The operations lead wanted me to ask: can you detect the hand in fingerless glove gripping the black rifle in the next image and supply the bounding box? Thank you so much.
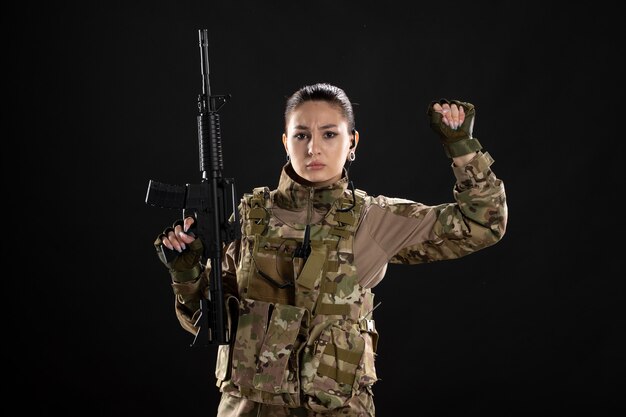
[154,218,203,282]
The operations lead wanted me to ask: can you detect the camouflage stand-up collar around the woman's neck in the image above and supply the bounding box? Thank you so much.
[274,162,348,211]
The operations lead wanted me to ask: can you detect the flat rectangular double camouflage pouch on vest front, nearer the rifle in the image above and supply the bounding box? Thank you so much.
[232,299,309,406]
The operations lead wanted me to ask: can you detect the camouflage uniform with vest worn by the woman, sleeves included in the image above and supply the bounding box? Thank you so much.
[168,152,507,416]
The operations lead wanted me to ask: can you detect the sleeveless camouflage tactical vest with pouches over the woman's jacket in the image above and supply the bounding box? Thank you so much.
[216,187,378,411]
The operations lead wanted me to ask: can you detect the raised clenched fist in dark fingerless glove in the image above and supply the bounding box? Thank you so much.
[427,98,482,158]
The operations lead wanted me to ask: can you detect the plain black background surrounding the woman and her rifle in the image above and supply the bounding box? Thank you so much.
[8,0,624,417]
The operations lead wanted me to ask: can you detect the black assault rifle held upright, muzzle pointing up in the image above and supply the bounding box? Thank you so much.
[146,29,241,346]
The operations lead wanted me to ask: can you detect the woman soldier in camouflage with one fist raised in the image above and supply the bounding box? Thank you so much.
[155,83,507,417]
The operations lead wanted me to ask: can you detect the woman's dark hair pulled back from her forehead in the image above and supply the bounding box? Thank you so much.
[285,83,354,132]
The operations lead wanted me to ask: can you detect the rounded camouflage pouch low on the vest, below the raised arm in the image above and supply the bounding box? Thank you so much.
[300,320,366,411]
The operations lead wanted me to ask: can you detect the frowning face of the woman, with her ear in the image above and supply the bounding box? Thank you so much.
[283,101,359,186]
